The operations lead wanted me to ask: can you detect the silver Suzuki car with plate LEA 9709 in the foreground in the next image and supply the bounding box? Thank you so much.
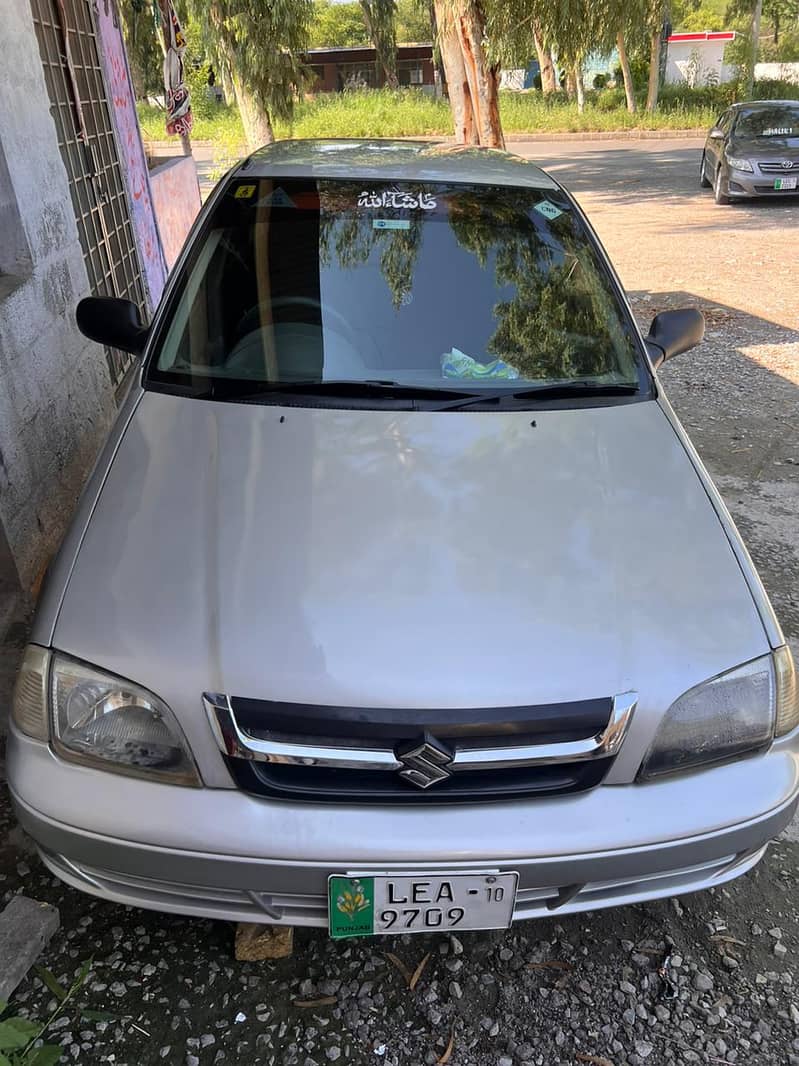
[9,141,799,937]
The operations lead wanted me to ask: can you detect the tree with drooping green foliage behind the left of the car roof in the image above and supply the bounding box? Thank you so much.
[187,0,313,149]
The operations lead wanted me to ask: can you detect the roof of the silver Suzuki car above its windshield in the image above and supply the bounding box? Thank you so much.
[232,139,559,189]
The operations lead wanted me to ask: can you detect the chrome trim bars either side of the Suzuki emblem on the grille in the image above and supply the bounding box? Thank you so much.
[202,692,638,773]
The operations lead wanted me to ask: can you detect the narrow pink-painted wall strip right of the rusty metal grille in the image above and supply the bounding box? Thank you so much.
[95,0,166,307]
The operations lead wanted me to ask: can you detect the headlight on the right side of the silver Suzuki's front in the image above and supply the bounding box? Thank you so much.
[640,648,784,777]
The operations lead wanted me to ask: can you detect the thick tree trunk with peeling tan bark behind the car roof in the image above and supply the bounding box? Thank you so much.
[436,0,505,148]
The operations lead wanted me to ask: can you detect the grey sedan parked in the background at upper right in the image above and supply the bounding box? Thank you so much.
[699,100,799,204]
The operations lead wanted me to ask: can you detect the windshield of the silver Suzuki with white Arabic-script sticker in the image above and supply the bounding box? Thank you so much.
[146,178,639,399]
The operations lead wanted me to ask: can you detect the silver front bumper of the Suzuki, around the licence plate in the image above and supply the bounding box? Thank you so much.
[9,732,799,925]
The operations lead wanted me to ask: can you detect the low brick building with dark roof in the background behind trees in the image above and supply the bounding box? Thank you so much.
[304,45,436,93]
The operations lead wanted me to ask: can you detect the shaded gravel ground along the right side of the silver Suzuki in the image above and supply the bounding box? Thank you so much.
[630,291,799,640]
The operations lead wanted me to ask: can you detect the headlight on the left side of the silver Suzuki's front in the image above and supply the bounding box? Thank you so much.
[12,645,200,786]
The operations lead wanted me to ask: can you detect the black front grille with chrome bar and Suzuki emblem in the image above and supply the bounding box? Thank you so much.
[205,693,635,806]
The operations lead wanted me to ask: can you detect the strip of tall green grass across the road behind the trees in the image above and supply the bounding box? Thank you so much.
[138,77,796,146]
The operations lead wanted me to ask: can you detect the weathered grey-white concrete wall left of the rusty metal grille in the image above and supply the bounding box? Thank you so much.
[0,0,115,587]
